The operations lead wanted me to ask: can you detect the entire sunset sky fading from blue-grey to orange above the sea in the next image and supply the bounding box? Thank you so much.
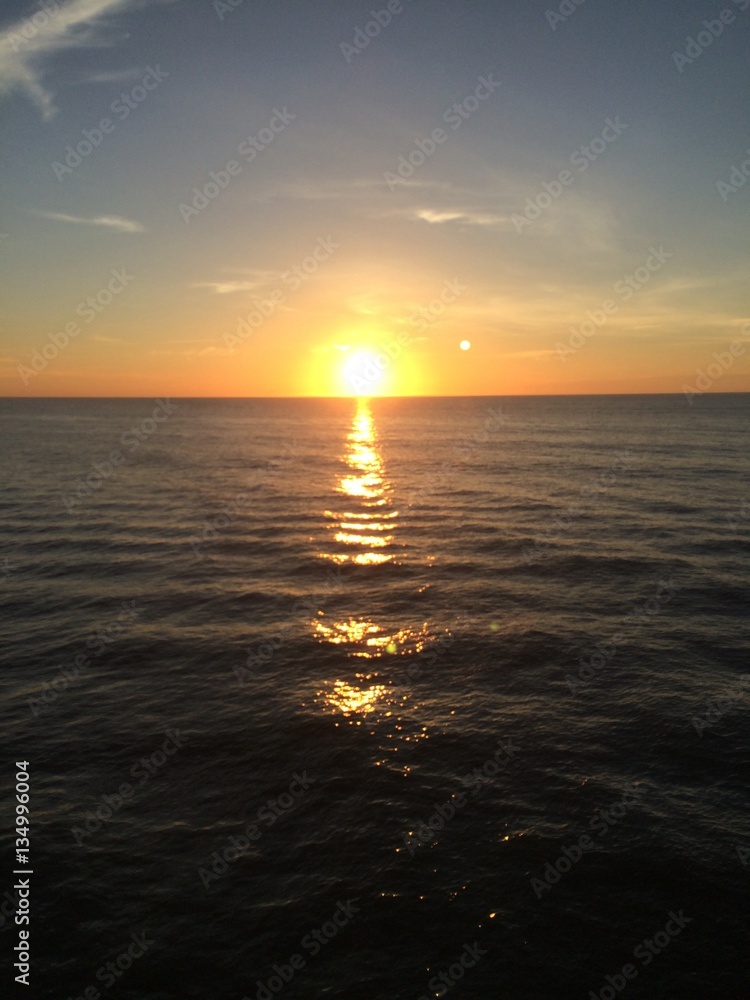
[0,0,750,396]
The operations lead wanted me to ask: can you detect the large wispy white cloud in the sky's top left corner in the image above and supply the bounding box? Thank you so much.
[0,0,164,120]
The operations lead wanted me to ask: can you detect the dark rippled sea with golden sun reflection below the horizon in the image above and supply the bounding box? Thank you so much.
[0,395,750,1000]
